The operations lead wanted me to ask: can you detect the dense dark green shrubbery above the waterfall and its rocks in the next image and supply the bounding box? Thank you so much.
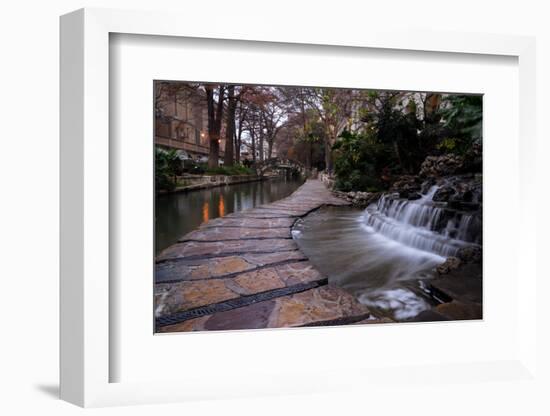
[333,92,483,191]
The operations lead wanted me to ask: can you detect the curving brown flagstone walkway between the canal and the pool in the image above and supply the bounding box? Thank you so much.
[155,180,376,332]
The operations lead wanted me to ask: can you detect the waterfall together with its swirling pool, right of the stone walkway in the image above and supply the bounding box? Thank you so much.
[293,186,478,320]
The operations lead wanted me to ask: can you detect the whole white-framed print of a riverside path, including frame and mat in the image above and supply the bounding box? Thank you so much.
[61,9,537,406]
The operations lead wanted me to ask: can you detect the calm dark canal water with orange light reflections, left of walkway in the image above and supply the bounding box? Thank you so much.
[155,177,303,254]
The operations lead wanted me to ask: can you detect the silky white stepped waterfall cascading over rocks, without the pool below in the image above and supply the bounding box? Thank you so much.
[363,186,480,257]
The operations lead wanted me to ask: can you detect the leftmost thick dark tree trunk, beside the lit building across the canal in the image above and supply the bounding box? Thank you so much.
[204,84,225,168]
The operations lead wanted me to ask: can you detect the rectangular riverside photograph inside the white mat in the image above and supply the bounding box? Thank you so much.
[151,80,483,333]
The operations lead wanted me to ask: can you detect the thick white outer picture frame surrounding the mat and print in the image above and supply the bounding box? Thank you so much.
[60,9,540,406]
